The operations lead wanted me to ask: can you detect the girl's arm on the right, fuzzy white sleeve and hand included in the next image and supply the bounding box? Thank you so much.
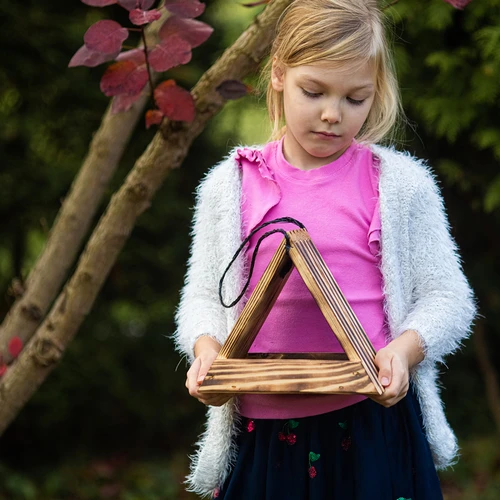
[373,164,476,406]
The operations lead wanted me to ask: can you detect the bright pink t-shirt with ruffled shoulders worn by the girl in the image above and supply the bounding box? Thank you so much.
[237,139,386,419]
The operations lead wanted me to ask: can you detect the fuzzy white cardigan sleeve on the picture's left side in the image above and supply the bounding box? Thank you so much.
[173,164,240,363]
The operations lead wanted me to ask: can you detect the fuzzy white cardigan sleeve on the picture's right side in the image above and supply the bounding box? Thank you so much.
[399,170,476,362]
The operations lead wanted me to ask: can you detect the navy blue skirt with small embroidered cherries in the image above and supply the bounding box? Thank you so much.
[214,388,443,500]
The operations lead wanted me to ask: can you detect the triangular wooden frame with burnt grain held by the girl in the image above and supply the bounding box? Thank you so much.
[199,229,384,394]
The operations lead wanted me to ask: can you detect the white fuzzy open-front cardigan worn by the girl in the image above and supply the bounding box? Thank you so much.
[174,146,476,496]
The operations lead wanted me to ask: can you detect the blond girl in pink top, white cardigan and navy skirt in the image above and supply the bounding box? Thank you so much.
[175,0,475,500]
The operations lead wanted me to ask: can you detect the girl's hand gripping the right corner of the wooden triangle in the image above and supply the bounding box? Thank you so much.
[370,330,424,408]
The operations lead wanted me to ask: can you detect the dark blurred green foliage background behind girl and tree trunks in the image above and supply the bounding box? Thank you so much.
[0,0,500,500]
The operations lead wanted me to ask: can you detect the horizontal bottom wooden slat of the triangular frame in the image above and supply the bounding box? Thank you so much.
[199,359,378,394]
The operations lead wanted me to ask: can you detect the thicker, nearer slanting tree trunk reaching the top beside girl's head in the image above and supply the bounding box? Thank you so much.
[0,0,291,433]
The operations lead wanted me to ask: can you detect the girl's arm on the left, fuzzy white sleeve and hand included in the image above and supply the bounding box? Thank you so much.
[174,158,240,406]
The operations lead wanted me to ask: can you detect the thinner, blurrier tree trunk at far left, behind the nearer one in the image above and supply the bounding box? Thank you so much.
[0,11,165,363]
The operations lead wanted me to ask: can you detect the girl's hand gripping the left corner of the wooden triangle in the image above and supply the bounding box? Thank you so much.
[186,337,233,406]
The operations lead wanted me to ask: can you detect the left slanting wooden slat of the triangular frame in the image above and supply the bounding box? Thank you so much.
[218,239,293,359]
